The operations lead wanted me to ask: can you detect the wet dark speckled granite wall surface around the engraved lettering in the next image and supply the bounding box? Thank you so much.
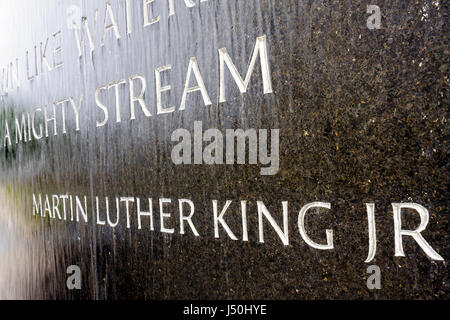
[0,0,450,299]
